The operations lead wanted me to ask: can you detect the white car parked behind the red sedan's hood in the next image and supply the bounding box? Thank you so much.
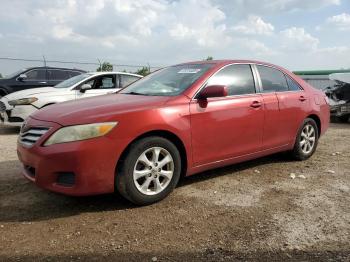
[0,72,142,126]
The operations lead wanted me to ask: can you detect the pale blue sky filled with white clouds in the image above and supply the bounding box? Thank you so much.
[0,0,350,74]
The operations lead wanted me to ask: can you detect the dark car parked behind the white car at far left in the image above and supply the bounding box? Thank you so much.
[0,67,86,97]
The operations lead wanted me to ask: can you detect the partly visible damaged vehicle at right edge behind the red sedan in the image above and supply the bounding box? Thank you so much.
[324,73,350,123]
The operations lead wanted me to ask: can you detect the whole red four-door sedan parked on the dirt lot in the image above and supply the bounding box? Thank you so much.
[17,60,329,205]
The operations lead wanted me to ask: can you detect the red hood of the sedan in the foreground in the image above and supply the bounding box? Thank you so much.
[31,94,169,126]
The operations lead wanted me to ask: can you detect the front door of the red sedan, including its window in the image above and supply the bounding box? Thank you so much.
[190,64,264,165]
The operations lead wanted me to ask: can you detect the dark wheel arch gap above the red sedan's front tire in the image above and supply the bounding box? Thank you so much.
[116,130,188,180]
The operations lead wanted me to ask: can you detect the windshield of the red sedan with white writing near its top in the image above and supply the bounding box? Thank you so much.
[120,64,213,96]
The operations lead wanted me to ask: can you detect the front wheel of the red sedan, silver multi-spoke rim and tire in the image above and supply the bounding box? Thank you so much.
[116,136,181,205]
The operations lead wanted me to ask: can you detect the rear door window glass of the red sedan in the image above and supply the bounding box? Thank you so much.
[257,65,288,93]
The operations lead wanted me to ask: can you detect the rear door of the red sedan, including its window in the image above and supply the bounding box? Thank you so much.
[256,65,306,149]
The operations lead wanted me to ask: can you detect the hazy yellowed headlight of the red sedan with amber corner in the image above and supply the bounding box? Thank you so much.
[44,122,118,146]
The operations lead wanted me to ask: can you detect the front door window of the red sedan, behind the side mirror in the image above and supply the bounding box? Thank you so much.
[207,65,255,96]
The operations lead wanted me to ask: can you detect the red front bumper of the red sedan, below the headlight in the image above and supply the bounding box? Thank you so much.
[17,118,120,196]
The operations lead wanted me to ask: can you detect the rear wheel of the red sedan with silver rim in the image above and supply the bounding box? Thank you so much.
[292,118,319,160]
